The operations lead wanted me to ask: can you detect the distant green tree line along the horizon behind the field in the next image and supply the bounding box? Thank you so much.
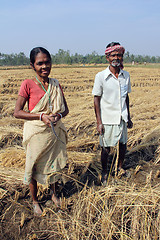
[0,49,160,66]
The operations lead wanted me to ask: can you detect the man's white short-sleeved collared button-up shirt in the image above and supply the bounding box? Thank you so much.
[92,67,131,125]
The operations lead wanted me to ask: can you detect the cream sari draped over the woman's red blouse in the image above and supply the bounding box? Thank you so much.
[23,78,67,184]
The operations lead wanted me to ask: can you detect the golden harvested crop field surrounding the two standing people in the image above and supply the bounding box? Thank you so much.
[0,65,160,239]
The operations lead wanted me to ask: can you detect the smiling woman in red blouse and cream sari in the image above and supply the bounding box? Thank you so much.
[14,47,69,215]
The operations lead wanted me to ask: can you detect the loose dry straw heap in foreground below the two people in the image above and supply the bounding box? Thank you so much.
[0,175,160,240]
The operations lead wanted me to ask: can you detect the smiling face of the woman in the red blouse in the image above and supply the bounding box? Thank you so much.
[32,52,52,78]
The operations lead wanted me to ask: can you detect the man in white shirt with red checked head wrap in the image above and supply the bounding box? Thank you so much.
[92,42,133,182]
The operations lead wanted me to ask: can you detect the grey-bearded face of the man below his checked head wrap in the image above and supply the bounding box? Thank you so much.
[106,51,123,67]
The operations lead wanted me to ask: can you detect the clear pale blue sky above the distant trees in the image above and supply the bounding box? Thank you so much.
[0,0,160,56]
